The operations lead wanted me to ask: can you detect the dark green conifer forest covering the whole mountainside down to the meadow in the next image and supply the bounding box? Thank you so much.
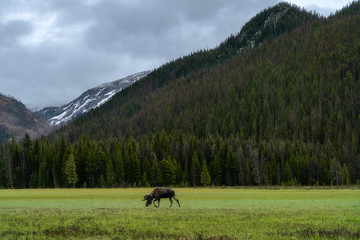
[0,2,360,188]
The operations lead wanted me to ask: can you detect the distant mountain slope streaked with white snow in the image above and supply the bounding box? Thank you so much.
[36,71,150,127]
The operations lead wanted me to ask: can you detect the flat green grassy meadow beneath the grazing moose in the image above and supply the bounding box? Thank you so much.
[0,188,360,239]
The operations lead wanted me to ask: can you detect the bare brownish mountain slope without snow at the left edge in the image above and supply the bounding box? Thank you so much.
[0,94,51,143]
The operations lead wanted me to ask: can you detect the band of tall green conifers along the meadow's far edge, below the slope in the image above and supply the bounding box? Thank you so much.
[0,131,360,188]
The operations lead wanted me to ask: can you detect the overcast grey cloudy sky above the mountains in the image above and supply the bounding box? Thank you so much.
[0,0,351,110]
